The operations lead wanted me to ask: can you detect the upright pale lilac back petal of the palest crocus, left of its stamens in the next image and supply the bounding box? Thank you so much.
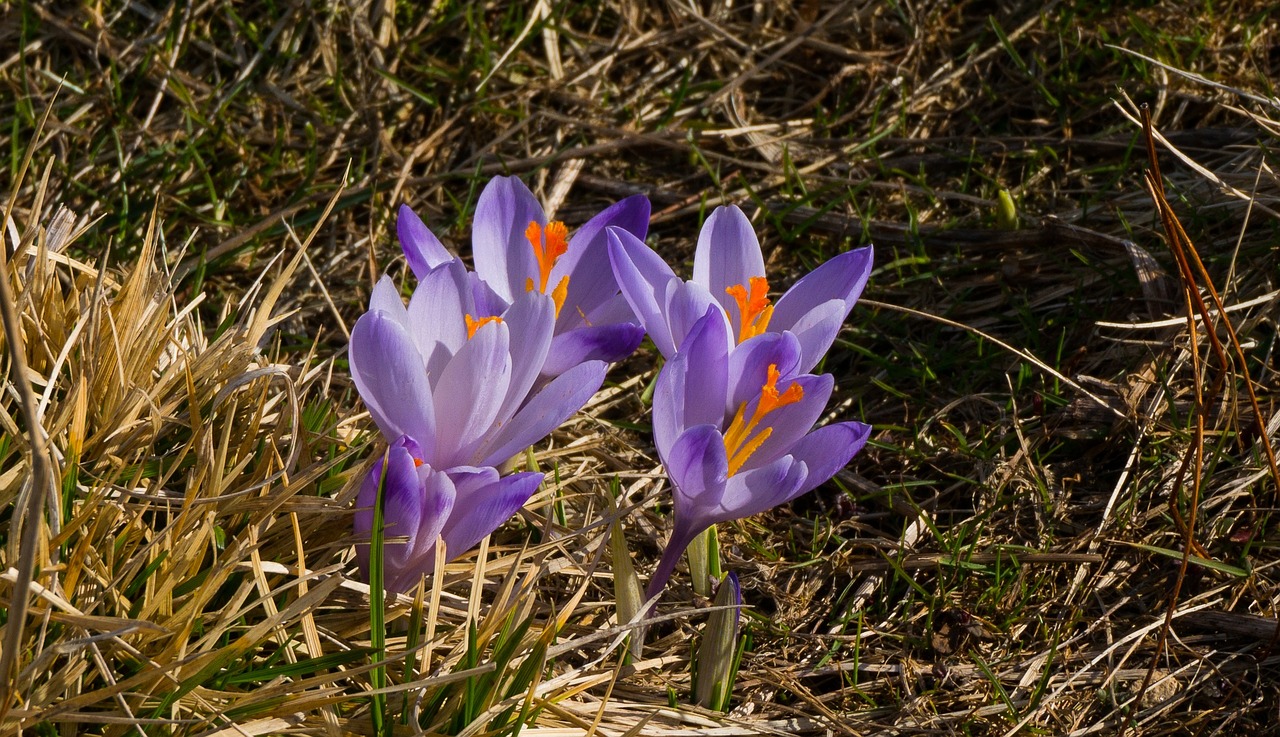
[406,261,468,376]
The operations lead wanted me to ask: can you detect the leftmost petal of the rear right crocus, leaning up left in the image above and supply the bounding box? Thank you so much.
[605,228,680,358]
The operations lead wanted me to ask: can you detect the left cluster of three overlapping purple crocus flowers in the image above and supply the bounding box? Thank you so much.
[349,178,649,591]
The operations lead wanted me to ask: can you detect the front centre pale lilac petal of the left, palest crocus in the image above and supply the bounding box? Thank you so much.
[431,322,511,466]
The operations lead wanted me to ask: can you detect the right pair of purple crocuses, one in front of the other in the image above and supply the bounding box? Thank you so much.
[609,206,872,596]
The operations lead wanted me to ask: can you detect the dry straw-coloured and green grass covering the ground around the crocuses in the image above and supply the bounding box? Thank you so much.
[0,0,1280,736]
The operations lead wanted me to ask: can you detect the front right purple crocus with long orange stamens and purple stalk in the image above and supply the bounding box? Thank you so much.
[648,307,870,598]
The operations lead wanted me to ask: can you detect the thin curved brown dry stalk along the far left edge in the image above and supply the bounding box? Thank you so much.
[0,92,58,720]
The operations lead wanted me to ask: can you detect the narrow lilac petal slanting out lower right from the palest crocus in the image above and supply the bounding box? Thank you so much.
[472,361,605,466]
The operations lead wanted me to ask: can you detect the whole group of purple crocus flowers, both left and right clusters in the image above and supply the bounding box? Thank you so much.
[349,177,872,598]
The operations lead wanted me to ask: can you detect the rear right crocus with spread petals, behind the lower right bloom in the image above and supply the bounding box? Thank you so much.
[608,205,872,372]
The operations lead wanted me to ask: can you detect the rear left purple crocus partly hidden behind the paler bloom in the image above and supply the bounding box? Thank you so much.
[397,177,649,376]
